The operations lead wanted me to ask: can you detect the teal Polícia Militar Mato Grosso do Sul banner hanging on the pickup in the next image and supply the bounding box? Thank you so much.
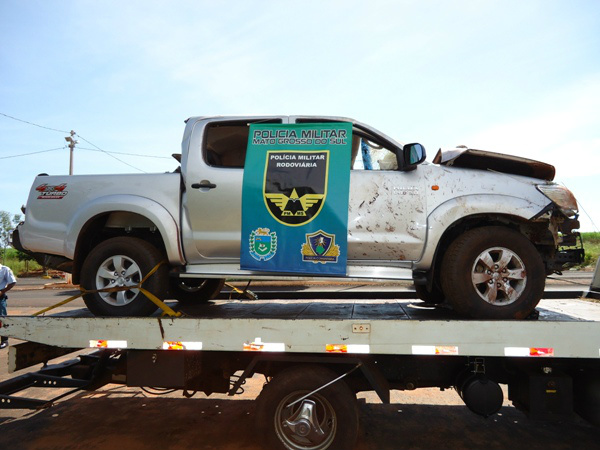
[240,123,352,275]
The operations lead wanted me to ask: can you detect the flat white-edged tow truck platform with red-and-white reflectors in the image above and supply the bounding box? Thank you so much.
[0,299,600,359]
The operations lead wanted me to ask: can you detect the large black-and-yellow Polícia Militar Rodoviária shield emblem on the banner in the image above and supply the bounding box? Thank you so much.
[263,150,329,227]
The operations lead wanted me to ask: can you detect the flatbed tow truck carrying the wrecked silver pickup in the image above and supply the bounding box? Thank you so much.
[0,269,600,449]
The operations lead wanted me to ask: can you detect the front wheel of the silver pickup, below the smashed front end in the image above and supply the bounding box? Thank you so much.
[441,226,546,319]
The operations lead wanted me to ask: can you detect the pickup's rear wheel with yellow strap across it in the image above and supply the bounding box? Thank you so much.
[81,237,168,317]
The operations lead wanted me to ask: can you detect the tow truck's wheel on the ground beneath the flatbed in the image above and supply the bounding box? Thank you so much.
[256,366,358,450]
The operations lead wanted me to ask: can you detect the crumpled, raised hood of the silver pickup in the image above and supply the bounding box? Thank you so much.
[433,148,556,181]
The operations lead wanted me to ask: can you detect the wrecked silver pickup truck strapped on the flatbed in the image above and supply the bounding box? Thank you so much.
[13,116,583,319]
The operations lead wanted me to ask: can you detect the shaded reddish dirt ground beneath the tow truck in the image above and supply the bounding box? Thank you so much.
[0,366,600,450]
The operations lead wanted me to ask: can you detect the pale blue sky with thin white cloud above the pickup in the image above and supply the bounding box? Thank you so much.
[0,0,600,231]
